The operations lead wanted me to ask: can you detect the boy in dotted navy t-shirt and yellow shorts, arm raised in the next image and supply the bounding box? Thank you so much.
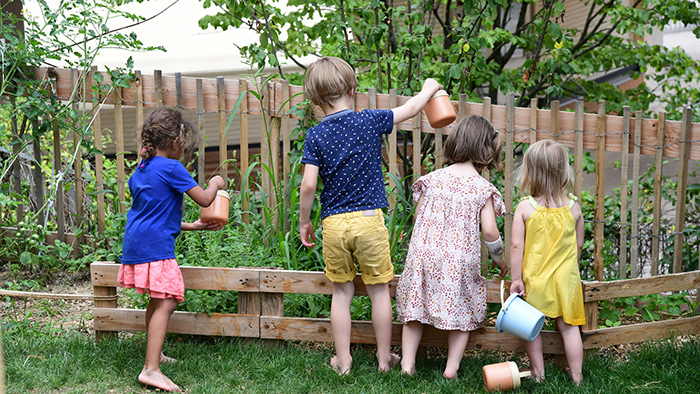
[299,57,441,375]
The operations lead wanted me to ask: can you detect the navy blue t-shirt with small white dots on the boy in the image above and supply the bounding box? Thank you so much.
[301,109,394,218]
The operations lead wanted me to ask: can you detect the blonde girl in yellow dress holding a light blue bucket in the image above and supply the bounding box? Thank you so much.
[510,140,586,384]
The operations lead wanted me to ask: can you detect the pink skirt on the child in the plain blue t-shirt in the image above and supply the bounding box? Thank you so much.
[118,259,185,302]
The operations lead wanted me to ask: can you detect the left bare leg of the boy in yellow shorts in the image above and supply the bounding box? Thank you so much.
[331,282,355,375]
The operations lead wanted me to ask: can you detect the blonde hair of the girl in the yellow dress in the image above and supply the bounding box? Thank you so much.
[518,140,574,207]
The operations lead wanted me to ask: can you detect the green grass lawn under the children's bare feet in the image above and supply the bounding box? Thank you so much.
[3,329,700,394]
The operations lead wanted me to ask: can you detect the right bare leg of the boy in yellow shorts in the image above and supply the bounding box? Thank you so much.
[367,283,399,372]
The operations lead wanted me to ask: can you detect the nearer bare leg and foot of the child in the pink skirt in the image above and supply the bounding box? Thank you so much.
[138,298,181,392]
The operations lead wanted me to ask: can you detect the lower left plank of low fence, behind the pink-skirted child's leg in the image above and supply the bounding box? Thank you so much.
[93,308,260,338]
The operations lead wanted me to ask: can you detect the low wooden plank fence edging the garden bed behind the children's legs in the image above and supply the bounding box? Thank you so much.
[90,262,700,354]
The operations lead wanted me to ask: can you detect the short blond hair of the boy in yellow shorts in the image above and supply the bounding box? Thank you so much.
[304,56,357,107]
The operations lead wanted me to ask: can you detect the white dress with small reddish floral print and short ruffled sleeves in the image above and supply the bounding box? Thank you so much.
[396,169,505,331]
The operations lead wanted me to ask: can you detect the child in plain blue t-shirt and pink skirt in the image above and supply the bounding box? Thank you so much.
[119,107,225,392]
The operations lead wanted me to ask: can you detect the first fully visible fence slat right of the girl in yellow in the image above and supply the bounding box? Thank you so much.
[593,100,606,281]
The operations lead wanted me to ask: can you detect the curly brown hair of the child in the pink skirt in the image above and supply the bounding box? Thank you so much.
[138,107,198,159]
